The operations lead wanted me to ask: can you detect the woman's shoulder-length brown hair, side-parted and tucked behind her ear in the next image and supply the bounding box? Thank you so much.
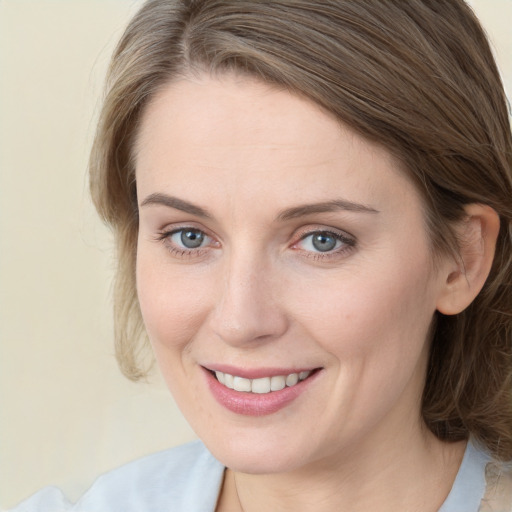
[90,0,512,459]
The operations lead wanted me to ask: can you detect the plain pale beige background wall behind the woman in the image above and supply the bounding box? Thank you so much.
[0,0,512,508]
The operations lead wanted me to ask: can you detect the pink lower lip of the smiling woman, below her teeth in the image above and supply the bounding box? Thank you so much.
[205,370,319,416]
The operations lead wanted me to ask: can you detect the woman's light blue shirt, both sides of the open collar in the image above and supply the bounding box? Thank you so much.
[11,441,512,512]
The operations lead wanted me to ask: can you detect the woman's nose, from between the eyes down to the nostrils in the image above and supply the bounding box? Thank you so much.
[207,249,288,346]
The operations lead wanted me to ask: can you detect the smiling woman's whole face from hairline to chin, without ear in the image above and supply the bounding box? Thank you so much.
[136,76,444,473]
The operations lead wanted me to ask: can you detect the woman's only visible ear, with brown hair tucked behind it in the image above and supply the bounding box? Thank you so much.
[437,204,500,315]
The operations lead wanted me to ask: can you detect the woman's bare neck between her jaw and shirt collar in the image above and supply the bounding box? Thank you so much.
[217,432,465,512]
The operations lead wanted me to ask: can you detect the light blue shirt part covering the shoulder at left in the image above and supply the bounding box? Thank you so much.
[12,441,224,512]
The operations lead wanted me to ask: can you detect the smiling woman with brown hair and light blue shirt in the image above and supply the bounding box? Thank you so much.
[13,0,512,512]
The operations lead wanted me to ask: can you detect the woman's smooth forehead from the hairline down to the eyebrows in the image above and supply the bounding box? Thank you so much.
[135,72,422,216]
